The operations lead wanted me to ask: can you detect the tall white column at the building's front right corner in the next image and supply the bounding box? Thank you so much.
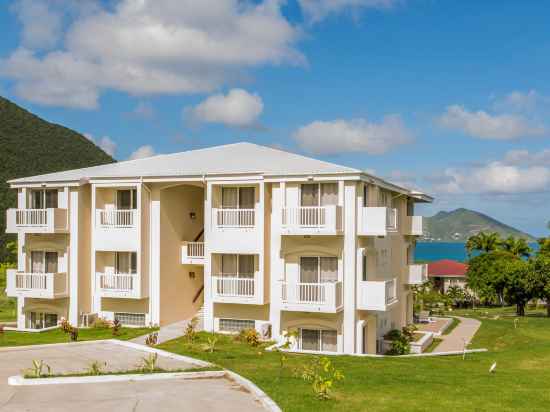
[339,181,357,354]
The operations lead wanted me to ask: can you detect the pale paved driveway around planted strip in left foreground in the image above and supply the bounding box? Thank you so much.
[0,342,265,412]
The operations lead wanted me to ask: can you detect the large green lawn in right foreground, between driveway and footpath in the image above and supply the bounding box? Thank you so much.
[159,308,550,412]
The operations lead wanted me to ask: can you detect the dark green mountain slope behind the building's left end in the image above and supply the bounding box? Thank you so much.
[0,96,114,262]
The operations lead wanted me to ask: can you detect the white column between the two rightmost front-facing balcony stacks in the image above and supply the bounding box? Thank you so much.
[269,182,286,339]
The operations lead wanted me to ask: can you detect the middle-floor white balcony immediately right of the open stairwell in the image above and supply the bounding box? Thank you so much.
[212,275,258,303]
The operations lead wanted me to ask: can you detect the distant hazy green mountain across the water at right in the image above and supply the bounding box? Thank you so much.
[424,208,535,242]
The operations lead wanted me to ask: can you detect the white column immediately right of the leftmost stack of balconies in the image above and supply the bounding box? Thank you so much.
[69,188,80,325]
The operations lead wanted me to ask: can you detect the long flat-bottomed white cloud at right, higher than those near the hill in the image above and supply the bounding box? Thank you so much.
[438,105,546,140]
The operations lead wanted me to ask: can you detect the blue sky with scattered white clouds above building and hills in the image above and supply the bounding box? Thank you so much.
[0,0,550,235]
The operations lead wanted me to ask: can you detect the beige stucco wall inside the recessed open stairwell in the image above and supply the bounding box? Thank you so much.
[160,185,204,325]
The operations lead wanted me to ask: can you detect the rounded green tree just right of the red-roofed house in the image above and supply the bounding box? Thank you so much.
[467,250,519,304]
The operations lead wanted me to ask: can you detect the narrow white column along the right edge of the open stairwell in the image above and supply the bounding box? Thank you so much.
[203,182,214,332]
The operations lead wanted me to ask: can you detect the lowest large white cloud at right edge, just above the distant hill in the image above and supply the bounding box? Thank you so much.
[434,161,550,194]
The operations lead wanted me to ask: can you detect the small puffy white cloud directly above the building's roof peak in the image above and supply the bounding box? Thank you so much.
[184,89,264,127]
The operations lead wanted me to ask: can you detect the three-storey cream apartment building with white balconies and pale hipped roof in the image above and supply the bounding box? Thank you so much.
[7,143,432,354]
